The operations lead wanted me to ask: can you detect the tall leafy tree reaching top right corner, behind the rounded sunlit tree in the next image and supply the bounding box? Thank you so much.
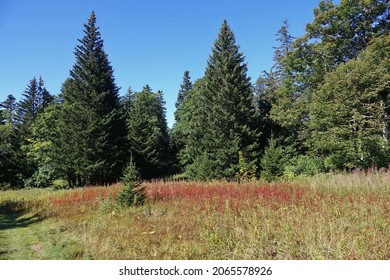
[271,0,390,153]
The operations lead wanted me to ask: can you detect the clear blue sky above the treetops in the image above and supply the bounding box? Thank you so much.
[0,0,326,126]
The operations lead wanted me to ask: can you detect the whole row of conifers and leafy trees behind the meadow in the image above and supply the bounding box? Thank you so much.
[0,0,390,188]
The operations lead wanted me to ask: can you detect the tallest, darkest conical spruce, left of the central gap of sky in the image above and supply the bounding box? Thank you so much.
[59,12,127,185]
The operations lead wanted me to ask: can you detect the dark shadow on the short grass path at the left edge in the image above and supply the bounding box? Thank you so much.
[0,201,43,231]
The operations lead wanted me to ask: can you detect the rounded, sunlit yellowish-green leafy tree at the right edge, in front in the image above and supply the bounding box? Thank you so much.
[310,36,390,168]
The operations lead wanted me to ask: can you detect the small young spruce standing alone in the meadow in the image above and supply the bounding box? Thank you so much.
[116,159,146,207]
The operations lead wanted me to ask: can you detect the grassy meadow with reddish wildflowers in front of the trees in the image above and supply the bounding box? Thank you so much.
[0,170,390,260]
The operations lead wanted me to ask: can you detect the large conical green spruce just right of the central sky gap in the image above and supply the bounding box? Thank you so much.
[183,21,259,179]
